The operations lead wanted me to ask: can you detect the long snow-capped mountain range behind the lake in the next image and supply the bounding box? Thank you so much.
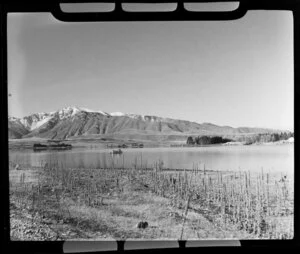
[8,106,279,140]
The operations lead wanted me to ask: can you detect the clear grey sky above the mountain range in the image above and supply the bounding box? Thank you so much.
[8,7,294,131]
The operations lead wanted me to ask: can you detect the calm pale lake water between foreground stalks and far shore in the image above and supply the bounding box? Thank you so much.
[9,144,294,174]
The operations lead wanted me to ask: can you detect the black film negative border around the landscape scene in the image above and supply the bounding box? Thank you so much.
[1,0,300,253]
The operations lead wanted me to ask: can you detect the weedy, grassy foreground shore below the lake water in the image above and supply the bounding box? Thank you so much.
[10,162,293,240]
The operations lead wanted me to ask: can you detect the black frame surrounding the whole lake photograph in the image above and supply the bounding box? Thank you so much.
[0,0,300,253]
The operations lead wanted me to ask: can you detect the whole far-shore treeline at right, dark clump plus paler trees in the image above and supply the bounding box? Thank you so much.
[186,132,294,145]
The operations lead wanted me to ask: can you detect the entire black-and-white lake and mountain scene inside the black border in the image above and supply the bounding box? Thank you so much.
[7,3,294,241]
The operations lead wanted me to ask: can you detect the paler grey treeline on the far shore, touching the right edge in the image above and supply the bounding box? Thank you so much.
[237,132,294,145]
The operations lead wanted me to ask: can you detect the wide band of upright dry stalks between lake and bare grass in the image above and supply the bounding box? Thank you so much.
[9,157,293,239]
